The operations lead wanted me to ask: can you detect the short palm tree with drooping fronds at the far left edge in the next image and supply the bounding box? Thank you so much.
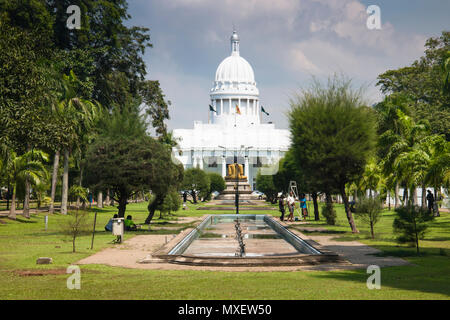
[7,151,48,219]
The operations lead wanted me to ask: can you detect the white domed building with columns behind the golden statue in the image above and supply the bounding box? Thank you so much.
[173,31,290,189]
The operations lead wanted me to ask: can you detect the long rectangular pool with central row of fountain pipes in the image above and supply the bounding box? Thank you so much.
[169,214,322,259]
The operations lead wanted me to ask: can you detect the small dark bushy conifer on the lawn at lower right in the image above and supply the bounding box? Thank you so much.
[393,205,434,254]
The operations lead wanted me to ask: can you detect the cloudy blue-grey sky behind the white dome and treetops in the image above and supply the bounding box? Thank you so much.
[128,0,450,129]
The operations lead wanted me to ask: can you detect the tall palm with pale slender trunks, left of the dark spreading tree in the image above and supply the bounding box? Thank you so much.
[50,71,98,214]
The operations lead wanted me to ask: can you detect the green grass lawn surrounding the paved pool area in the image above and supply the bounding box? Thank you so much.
[0,203,450,300]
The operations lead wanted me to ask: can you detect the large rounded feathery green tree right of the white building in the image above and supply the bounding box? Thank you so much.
[289,77,376,233]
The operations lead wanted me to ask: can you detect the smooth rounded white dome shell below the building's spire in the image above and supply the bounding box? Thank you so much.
[215,55,255,85]
